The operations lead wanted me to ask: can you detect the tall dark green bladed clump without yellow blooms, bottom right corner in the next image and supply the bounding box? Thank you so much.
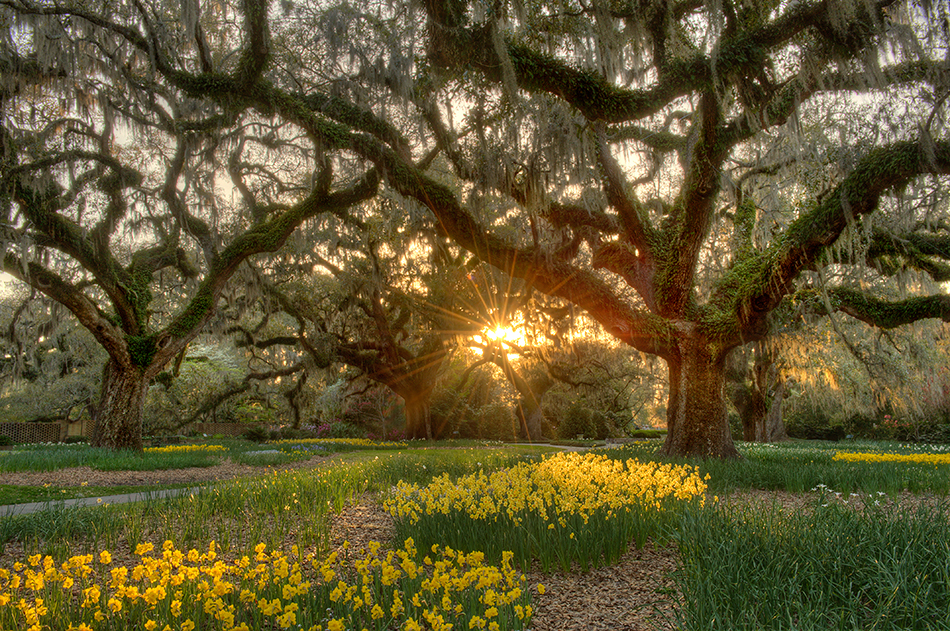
[676,503,950,631]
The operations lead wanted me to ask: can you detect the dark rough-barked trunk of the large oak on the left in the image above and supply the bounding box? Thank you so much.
[92,359,148,451]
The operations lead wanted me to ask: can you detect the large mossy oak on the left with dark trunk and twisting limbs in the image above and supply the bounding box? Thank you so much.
[0,0,378,449]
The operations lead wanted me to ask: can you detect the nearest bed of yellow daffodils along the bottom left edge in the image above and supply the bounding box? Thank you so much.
[0,539,543,631]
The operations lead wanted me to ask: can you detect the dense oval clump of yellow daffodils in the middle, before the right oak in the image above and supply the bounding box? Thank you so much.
[385,453,706,571]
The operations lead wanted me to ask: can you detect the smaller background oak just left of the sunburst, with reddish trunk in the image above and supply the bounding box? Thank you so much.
[238,212,466,439]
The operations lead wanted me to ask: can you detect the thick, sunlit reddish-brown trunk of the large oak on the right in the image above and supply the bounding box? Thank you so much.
[661,337,741,458]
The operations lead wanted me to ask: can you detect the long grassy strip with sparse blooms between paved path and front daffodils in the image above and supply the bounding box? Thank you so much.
[0,447,552,554]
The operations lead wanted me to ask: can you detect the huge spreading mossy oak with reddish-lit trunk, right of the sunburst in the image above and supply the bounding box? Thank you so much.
[404,0,950,457]
